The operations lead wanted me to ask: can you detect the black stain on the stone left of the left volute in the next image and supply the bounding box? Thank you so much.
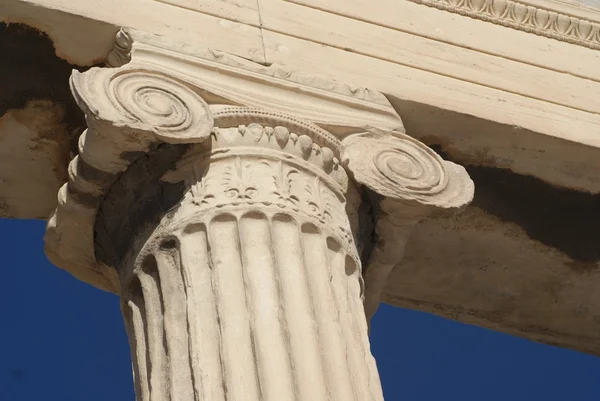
[0,23,85,153]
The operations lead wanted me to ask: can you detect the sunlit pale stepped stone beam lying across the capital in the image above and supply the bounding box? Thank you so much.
[0,0,600,156]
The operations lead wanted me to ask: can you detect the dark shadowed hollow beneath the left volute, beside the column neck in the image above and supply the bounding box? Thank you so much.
[94,144,189,268]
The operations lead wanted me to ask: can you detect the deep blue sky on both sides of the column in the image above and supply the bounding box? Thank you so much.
[0,219,600,401]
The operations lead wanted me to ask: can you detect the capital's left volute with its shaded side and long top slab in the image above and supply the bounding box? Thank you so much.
[45,30,403,292]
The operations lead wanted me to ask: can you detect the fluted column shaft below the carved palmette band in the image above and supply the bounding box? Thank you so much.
[124,212,380,401]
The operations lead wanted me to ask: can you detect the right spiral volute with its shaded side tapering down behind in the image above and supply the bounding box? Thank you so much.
[342,129,474,318]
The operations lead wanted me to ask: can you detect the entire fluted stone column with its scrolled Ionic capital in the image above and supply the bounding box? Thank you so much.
[45,30,474,401]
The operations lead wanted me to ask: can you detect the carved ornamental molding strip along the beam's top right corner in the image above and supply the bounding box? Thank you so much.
[409,0,600,50]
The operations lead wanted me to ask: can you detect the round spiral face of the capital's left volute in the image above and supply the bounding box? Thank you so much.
[71,68,213,143]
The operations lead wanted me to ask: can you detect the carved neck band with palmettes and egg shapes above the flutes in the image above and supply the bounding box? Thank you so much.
[163,120,358,247]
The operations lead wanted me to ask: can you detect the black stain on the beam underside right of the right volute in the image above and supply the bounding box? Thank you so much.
[430,144,600,266]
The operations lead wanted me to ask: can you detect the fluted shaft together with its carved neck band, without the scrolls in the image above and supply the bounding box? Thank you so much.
[122,119,383,401]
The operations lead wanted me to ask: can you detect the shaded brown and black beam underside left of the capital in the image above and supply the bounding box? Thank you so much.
[0,24,84,219]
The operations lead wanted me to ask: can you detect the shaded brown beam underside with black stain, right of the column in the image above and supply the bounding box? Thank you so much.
[383,166,600,354]
